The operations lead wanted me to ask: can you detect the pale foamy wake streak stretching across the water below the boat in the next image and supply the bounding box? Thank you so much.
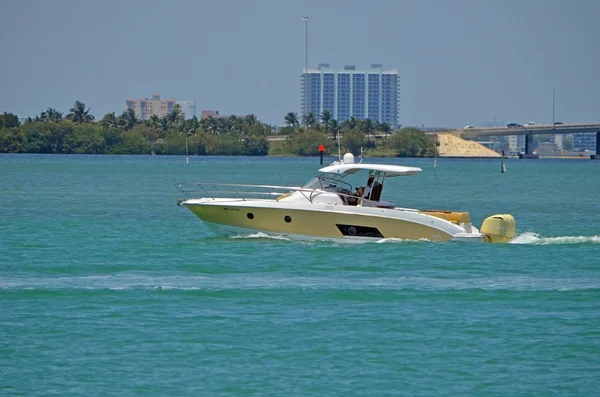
[0,271,600,290]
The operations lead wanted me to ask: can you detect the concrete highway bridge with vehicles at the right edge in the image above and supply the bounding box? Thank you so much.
[450,124,600,160]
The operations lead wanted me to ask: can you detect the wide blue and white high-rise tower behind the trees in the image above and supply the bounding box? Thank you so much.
[300,63,400,127]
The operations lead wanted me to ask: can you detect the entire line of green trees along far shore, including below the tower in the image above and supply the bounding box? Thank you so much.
[0,105,435,157]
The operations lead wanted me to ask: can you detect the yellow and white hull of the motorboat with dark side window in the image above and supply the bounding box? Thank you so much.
[183,199,482,243]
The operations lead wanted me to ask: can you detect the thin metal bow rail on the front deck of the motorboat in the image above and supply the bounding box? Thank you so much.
[175,182,317,205]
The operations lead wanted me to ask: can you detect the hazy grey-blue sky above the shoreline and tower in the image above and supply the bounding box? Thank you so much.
[0,0,600,128]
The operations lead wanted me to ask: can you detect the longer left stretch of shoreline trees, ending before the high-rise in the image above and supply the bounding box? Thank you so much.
[0,101,272,156]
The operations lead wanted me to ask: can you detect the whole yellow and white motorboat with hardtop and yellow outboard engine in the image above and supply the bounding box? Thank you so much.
[175,153,515,243]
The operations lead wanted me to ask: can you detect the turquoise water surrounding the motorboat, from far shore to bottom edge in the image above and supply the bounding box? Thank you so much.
[0,155,600,396]
